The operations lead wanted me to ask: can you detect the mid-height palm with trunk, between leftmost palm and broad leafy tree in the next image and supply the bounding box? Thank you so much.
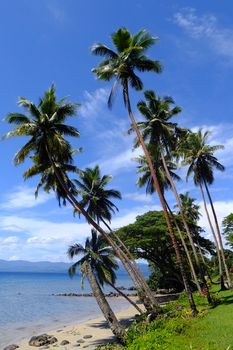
[74,165,159,310]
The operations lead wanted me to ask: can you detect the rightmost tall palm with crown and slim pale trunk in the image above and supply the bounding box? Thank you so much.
[181,129,231,286]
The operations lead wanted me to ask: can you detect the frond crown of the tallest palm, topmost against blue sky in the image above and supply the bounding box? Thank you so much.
[91,28,162,106]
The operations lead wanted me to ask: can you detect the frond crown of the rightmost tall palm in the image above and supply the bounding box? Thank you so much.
[181,129,225,185]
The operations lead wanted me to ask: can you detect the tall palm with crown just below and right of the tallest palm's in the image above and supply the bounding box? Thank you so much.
[135,90,211,303]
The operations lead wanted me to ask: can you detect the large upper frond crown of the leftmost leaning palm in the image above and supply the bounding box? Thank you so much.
[5,85,79,164]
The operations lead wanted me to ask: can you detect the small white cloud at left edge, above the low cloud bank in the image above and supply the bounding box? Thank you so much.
[0,186,51,211]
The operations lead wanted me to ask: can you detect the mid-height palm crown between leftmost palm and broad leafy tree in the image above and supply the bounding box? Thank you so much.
[74,165,121,223]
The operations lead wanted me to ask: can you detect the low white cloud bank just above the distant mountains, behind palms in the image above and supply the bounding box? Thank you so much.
[0,201,159,261]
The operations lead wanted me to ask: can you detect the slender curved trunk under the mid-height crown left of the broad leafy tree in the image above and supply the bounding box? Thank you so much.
[102,219,157,308]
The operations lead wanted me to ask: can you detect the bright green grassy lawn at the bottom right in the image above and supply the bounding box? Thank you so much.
[124,288,233,350]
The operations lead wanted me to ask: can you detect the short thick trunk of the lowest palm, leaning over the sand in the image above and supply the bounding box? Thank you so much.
[85,263,125,342]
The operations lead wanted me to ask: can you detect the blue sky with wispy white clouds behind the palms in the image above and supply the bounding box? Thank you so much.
[0,0,233,261]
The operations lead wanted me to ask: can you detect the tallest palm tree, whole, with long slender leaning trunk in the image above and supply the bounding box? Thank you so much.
[92,28,197,314]
